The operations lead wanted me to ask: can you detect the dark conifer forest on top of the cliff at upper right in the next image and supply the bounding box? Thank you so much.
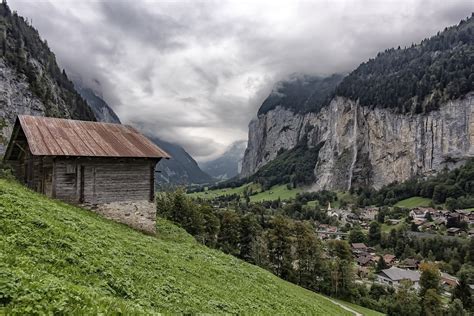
[335,16,474,113]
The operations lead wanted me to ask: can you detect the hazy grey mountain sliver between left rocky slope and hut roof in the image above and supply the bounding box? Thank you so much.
[73,78,120,124]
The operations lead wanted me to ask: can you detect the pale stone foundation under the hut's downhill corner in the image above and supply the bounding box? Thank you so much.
[88,201,156,234]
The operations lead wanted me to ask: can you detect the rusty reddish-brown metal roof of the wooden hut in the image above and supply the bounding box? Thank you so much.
[18,115,170,158]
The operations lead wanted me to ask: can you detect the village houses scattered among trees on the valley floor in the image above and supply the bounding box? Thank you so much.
[316,204,474,297]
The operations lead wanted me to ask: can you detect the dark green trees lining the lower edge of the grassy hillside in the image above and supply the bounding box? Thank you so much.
[156,190,474,315]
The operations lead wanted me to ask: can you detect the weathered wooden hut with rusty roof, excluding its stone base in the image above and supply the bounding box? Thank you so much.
[4,115,170,204]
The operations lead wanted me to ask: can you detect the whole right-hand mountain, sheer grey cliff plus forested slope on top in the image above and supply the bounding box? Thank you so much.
[241,17,474,190]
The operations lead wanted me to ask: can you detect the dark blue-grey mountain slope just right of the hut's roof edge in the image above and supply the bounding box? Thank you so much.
[151,137,214,186]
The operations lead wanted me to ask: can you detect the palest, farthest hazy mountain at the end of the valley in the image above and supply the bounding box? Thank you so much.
[200,140,247,180]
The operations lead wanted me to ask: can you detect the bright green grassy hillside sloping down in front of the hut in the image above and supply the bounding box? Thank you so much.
[0,180,350,315]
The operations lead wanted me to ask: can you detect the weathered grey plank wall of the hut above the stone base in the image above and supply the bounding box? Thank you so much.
[53,158,157,204]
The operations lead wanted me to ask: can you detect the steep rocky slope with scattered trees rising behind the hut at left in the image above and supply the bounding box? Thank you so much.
[0,1,96,155]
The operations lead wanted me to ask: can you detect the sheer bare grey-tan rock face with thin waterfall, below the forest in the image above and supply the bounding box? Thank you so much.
[241,93,474,190]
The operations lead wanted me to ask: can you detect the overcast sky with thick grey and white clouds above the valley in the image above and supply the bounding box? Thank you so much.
[8,0,474,160]
